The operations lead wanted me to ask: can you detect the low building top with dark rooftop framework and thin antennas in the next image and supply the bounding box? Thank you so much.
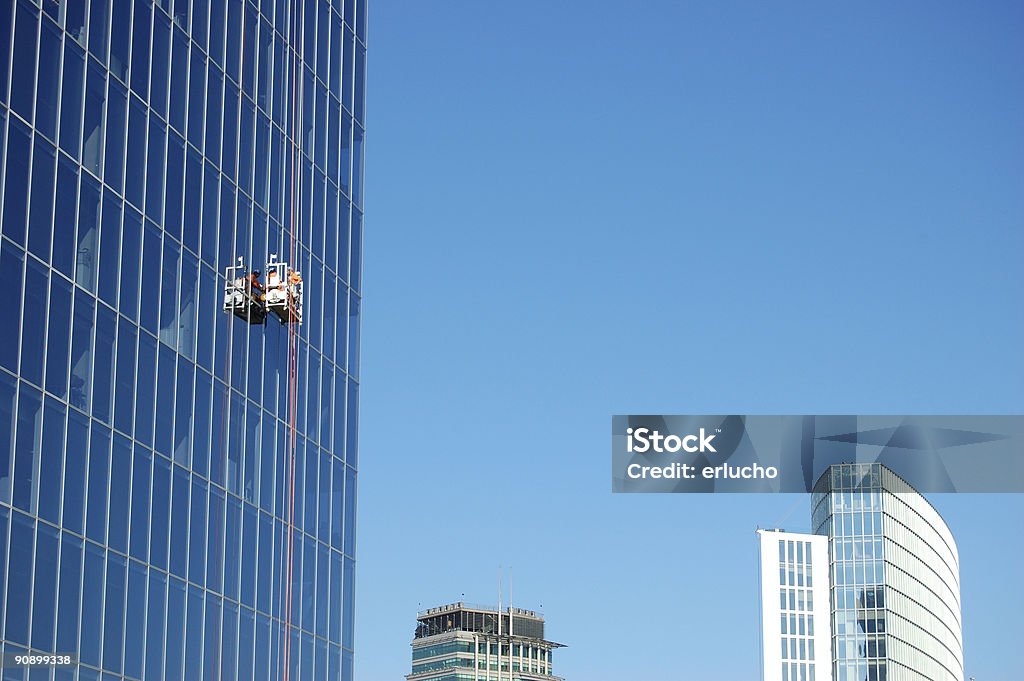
[406,602,562,681]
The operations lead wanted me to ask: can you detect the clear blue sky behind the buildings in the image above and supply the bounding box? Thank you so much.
[356,0,1024,681]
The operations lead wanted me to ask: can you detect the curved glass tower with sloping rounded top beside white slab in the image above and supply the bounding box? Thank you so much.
[812,464,964,681]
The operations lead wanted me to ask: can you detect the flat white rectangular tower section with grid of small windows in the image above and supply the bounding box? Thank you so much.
[758,529,831,681]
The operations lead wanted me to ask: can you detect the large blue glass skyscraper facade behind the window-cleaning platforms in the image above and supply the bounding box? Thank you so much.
[0,0,366,681]
